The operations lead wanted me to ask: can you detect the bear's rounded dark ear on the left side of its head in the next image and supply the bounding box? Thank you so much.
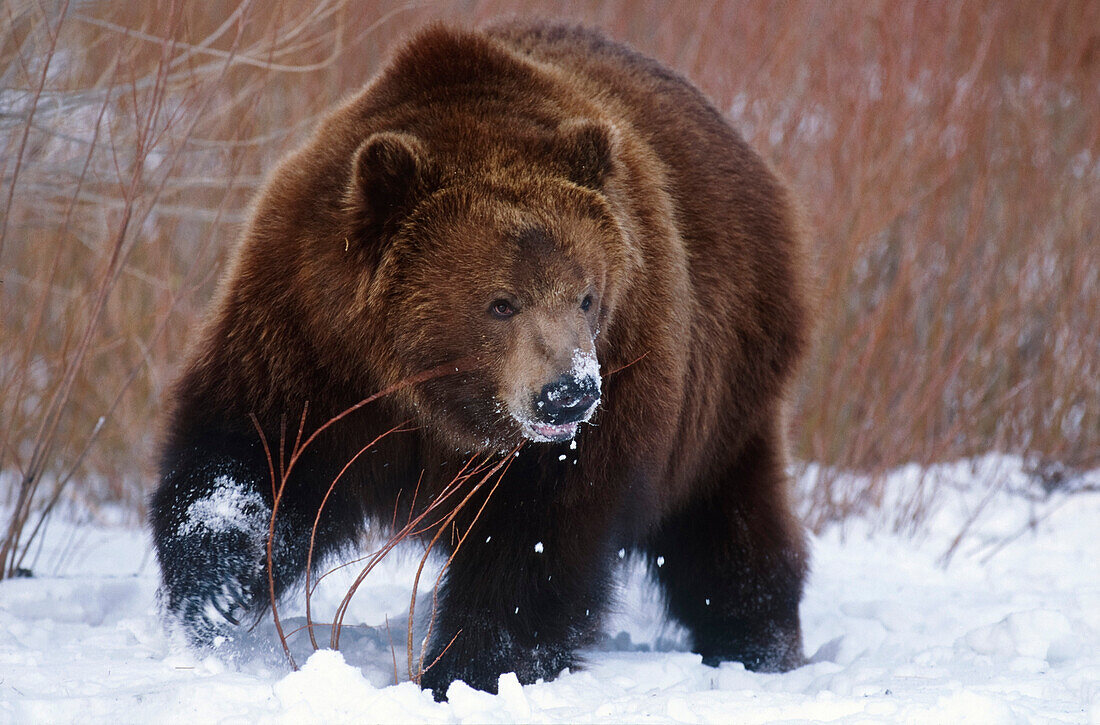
[348,131,435,238]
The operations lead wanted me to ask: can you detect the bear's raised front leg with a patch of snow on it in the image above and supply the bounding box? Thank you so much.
[150,430,343,648]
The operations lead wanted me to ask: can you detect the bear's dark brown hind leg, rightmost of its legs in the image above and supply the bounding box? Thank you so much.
[646,437,807,672]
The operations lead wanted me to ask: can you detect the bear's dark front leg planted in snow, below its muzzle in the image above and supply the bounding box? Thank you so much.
[420,501,613,701]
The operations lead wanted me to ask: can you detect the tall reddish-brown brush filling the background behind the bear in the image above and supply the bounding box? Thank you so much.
[0,0,1100,574]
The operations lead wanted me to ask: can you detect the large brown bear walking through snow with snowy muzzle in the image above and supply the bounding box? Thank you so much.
[151,23,810,696]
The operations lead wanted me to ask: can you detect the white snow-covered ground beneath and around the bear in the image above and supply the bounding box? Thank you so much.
[0,455,1100,724]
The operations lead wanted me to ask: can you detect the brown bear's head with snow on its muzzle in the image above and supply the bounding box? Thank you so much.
[345,121,633,450]
